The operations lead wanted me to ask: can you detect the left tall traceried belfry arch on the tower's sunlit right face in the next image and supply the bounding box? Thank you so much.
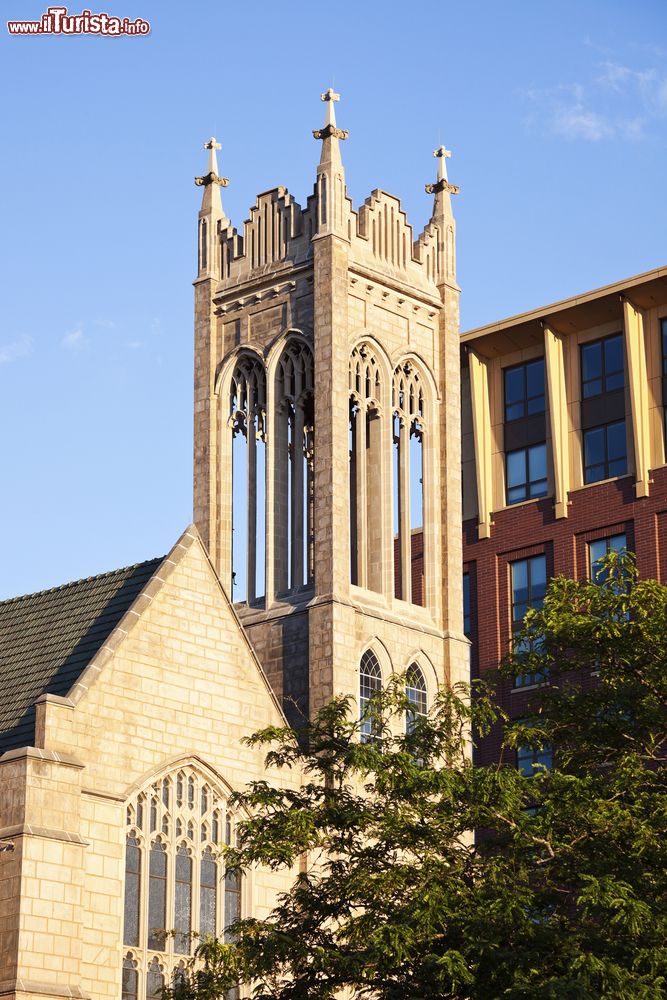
[349,344,383,592]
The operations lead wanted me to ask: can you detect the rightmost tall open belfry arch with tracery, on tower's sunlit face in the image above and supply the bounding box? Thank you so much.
[392,361,428,606]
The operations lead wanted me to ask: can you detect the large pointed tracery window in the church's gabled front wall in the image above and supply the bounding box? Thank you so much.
[122,766,241,1000]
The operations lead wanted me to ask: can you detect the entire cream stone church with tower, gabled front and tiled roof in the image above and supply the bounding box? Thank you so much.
[0,91,468,1000]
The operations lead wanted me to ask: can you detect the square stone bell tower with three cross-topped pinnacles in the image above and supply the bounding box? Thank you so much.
[194,90,469,720]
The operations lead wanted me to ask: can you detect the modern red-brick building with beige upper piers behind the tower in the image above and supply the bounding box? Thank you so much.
[461,267,667,766]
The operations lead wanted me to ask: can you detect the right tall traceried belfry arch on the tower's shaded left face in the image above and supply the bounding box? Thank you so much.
[275,341,315,593]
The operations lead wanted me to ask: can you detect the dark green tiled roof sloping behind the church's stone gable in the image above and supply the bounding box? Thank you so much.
[0,558,162,753]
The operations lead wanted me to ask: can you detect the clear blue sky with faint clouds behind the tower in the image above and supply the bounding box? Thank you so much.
[0,0,667,598]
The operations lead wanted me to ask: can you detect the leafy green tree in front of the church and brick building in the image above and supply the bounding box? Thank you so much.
[166,555,667,1000]
